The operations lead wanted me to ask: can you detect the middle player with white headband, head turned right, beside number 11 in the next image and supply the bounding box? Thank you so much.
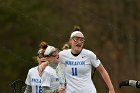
[41,46,59,93]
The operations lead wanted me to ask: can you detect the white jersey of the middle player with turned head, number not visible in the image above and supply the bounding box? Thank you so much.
[42,66,59,90]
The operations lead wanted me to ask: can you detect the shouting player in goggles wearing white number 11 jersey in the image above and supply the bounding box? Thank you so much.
[59,27,115,93]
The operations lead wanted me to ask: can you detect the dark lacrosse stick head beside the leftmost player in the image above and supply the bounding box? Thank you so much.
[9,79,25,93]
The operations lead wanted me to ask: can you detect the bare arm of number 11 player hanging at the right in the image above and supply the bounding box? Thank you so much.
[97,64,115,93]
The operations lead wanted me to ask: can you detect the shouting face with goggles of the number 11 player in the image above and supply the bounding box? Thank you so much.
[71,34,85,53]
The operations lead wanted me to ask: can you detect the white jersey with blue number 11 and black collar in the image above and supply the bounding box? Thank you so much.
[59,49,101,93]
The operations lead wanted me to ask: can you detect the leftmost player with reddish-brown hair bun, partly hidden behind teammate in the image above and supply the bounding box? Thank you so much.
[24,42,47,93]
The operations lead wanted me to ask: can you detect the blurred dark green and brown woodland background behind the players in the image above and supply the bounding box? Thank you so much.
[0,0,140,93]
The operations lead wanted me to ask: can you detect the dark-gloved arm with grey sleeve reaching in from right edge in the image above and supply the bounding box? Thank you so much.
[119,80,140,88]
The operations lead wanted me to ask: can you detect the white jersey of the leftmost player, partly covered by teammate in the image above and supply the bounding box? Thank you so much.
[25,67,42,93]
